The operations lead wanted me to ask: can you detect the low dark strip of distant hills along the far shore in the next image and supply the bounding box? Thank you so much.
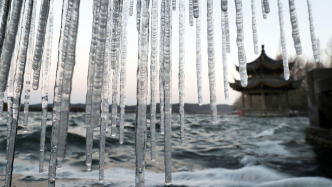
[0,103,233,114]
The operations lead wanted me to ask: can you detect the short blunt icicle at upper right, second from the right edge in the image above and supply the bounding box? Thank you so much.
[288,0,302,55]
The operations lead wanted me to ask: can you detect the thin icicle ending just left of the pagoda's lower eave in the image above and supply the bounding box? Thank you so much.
[221,12,229,99]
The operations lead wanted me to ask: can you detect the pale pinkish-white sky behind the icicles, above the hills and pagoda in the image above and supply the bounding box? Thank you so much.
[26,0,332,105]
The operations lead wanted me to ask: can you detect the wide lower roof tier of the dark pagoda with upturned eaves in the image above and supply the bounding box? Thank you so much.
[229,77,302,91]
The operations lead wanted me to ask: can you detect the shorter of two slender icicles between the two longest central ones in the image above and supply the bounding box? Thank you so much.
[159,0,166,134]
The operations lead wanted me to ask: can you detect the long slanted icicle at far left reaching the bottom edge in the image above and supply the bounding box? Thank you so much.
[6,0,33,186]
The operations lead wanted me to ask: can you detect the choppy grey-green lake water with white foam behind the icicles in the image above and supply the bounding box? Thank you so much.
[0,112,332,187]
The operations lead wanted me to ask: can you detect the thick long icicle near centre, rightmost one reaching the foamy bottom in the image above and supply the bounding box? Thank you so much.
[163,0,172,184]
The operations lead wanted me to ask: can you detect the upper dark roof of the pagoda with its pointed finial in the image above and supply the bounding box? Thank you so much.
[235,45,295,74]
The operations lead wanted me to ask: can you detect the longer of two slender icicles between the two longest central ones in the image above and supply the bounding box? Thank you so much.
[150,0,158,160]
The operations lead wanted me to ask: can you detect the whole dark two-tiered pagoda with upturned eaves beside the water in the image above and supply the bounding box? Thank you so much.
[229,45,302,116]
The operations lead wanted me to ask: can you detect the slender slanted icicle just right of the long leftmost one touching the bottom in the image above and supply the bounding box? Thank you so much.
[23,0,37,131]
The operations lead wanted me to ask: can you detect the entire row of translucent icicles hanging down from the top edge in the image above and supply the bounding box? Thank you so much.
[0,0,319,186]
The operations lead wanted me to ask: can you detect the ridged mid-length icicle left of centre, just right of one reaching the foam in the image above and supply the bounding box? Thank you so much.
[111,0,123,136]
